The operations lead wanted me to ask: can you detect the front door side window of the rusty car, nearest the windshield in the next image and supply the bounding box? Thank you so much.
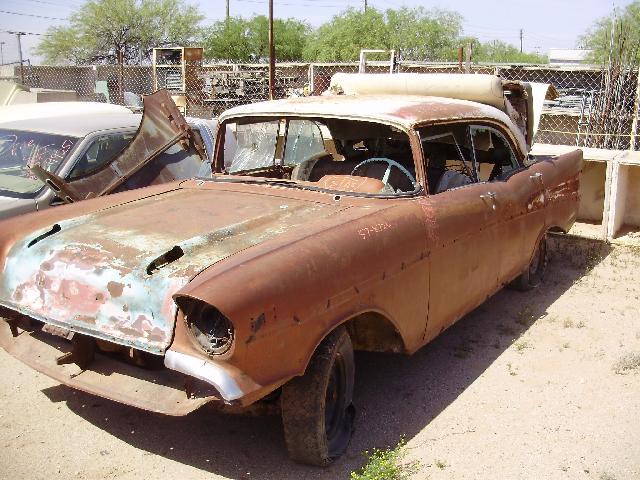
[418,123,476,194]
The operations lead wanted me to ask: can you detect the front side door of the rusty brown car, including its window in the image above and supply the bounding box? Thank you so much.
[418,123,499,342]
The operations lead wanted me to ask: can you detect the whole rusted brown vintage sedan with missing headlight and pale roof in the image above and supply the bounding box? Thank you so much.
[0,74,582,465]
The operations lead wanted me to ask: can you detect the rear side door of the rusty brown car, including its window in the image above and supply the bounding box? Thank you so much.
[470,125,546,284]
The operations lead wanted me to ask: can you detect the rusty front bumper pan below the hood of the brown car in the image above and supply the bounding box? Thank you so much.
[0,319,221,416]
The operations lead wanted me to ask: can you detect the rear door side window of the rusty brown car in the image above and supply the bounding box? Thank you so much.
[470,126,520,182]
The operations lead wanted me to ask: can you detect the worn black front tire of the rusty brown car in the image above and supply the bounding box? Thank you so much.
[281,327,355,466]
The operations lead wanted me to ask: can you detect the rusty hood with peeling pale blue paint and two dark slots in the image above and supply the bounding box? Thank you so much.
[0,187,348,354]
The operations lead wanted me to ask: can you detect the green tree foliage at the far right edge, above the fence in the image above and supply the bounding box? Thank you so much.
[580,0,640,65]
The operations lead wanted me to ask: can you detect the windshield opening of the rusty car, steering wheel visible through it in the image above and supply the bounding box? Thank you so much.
[216,118,419,196]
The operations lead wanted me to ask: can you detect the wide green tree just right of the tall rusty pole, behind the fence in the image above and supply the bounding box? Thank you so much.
[304,7,462,61]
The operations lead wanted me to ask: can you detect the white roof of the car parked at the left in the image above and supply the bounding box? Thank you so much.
[0,113,142,138]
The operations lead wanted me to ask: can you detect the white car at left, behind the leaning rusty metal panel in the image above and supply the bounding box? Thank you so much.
[0,102,217,219]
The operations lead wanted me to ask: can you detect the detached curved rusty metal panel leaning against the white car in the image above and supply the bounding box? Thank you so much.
[31,90,206,203]
